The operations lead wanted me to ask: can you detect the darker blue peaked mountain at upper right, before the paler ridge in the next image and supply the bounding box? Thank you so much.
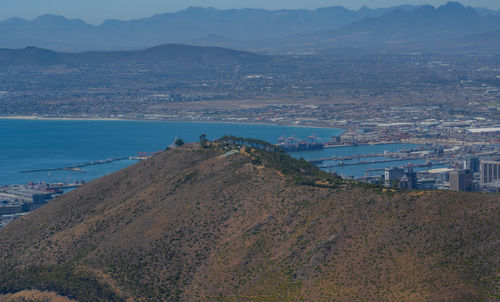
[282,2,500,47]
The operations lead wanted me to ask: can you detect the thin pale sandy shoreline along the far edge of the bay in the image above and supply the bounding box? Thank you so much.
[0,115,347,132]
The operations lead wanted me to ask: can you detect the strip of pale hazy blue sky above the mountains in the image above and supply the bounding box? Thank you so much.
[0,0,500,24]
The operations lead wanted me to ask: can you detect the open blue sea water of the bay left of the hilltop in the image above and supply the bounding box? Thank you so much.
[0,119,343,186]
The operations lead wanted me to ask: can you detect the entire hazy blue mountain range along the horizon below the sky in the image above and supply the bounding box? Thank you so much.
[0,2,500,51]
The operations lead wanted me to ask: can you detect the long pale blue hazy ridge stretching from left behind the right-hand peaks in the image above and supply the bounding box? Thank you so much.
[0,5,470,51]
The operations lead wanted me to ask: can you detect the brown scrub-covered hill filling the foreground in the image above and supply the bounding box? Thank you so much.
[0,142,500,301]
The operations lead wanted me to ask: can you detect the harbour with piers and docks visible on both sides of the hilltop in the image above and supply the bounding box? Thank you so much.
[0,133,494,231]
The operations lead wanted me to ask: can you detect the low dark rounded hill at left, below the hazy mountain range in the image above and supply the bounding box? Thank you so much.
[0,44,266,68]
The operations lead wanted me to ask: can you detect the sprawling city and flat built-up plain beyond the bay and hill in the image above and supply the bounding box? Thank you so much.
[0,52,500,225]
